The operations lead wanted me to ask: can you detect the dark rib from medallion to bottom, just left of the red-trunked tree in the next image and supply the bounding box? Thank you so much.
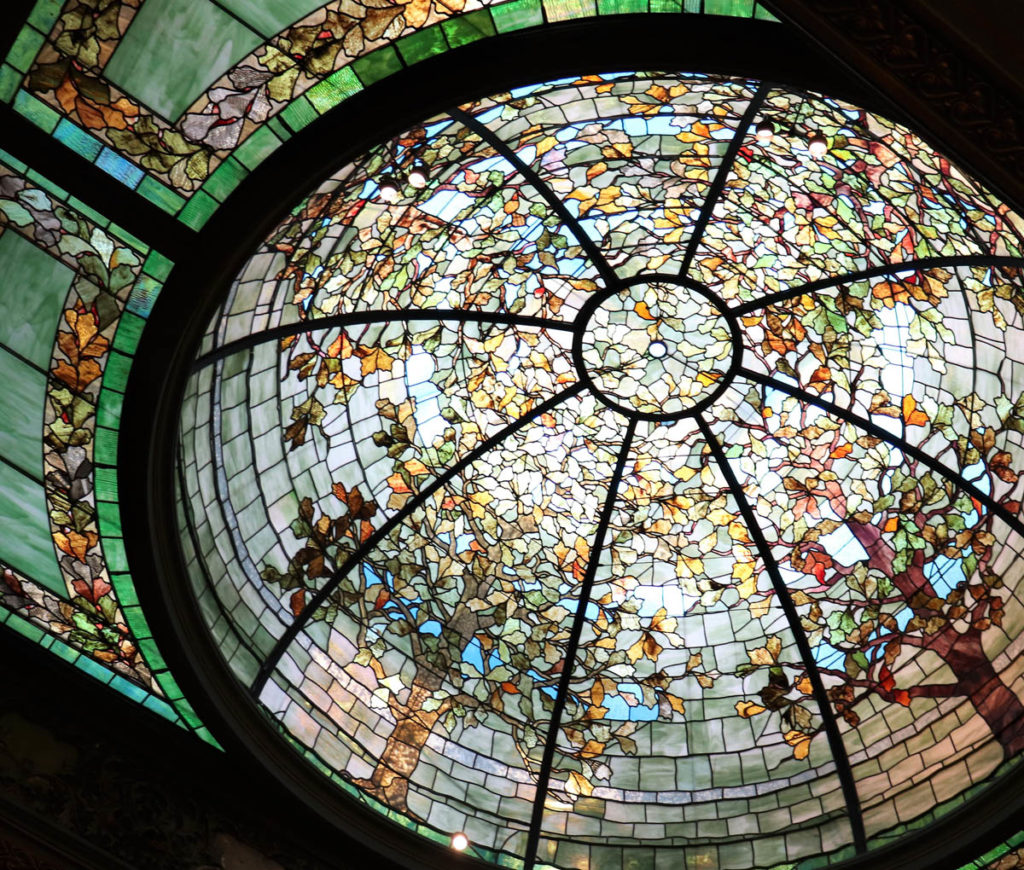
[697,416,867,854]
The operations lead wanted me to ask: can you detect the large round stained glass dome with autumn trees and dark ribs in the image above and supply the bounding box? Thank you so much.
[177,74,1024,870]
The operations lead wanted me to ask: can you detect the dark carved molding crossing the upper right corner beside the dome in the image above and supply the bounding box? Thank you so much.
[765,0,1024,211]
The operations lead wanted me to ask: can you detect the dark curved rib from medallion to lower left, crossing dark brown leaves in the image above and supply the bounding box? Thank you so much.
[250,383,585,697]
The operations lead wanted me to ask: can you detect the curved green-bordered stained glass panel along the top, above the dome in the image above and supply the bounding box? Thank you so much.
[0,0,777,228]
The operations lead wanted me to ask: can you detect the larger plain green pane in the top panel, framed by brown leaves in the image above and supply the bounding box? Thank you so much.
[103,0,263,122]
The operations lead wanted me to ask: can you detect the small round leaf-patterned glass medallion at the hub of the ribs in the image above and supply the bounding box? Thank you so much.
[578,278,733,419]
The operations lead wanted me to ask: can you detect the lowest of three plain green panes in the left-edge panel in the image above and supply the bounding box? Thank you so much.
[0,462,67,597]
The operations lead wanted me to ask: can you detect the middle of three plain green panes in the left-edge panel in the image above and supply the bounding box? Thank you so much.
[0,350,46,483]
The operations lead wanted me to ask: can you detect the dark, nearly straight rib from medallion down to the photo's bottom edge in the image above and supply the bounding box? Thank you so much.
[524,418,637,870]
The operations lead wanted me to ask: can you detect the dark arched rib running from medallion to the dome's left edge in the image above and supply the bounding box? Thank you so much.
[191,308,572,372]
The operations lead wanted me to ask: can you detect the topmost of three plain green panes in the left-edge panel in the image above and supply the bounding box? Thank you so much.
[0,230,75,371]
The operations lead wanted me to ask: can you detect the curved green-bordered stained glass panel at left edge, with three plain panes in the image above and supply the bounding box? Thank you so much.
[0,153,212,741]
